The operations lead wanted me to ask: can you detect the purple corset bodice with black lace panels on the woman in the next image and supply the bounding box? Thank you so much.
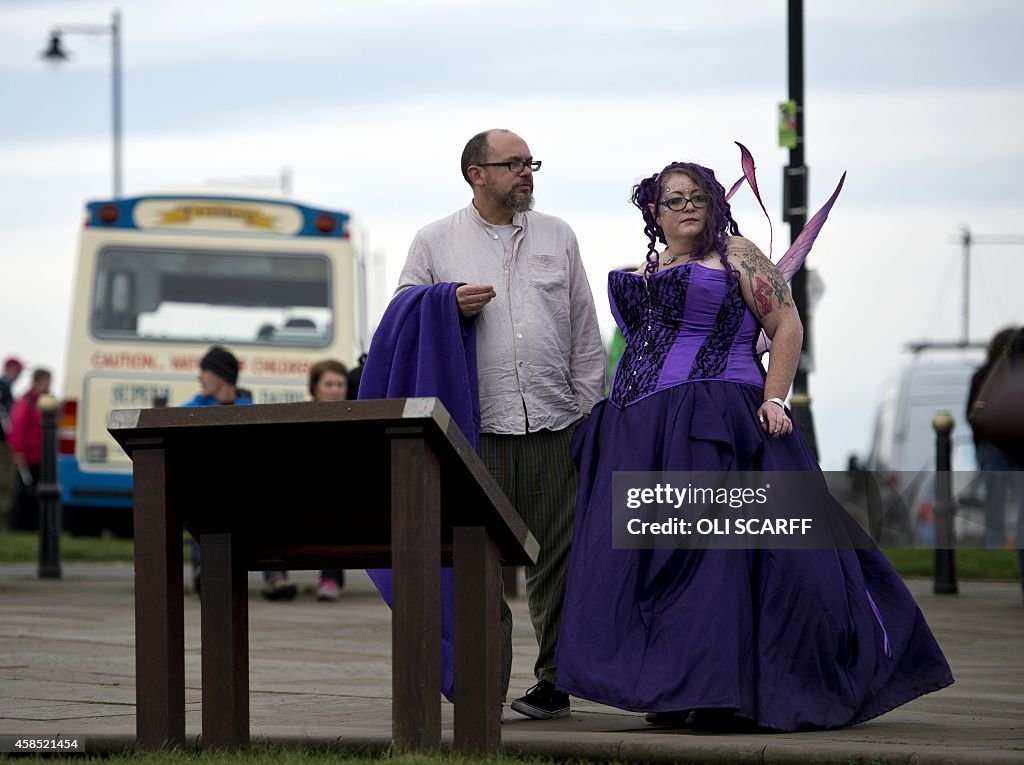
[608,262,764,409]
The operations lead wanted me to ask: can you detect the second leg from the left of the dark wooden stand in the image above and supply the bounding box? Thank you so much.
[200,534,249,749]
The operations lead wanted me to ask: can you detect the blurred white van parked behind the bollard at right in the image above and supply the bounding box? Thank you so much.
[863,345,985,545]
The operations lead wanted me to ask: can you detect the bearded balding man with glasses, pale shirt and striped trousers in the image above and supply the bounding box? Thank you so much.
[397,130,605,719]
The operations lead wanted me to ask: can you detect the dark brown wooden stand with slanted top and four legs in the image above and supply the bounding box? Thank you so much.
[108,398,538,752]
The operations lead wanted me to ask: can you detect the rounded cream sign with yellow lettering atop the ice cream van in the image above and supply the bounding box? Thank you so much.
[134,199,302,235]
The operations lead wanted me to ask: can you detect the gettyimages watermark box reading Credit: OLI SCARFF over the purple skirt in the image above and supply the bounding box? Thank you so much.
[611,471,874,550]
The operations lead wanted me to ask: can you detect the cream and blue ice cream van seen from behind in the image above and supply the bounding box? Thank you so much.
[57,196,365,534]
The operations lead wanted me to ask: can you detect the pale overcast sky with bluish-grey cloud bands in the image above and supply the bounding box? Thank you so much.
[0,0,1024,469]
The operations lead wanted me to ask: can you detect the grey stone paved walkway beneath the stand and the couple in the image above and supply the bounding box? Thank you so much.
[0,563,1024,765]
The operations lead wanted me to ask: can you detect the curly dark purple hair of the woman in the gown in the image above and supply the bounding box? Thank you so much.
[630,162,739,275]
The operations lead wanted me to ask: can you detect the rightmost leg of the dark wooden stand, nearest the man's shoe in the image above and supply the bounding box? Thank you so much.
[454,526,502,755]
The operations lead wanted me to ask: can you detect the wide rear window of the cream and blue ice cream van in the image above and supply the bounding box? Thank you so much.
[92,246,334,347]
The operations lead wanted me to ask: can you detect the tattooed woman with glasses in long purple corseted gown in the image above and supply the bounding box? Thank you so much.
[557,163,952,730]
